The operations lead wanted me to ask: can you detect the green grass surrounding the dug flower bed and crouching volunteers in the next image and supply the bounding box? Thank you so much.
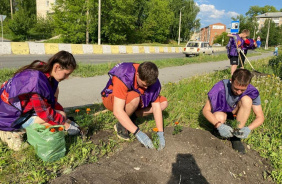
[0,52,282,183]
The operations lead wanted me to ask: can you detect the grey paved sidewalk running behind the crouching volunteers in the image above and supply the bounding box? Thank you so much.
[58,52,272,108]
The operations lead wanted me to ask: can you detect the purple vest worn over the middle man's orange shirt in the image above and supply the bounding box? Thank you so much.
[101,63,161,108]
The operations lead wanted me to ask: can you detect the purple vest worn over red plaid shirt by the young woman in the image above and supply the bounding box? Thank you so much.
[0,70,58,131]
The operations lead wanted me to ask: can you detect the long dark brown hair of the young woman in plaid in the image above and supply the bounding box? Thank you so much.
[15,51,77,75]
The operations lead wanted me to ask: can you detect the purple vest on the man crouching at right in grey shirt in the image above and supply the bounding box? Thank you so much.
[208,81,259,113]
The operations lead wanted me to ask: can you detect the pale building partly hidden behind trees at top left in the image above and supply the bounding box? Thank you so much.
[36,0,56,18]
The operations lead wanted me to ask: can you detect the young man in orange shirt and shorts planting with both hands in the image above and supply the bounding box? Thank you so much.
[101,62,168,150]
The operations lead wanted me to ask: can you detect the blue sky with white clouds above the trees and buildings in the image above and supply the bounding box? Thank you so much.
[195,0,282,28]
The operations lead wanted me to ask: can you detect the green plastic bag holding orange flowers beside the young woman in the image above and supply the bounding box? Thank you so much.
[26,123,66,162]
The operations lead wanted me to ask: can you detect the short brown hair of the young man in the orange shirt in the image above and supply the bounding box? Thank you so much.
[138,61,159,85]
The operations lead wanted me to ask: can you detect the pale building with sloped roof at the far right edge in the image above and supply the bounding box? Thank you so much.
[256,12,282,30]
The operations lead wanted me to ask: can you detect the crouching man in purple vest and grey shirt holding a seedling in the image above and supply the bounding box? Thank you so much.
[203,69,264,154]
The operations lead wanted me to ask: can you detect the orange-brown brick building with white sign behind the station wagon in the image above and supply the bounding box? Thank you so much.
[200,23,226,45]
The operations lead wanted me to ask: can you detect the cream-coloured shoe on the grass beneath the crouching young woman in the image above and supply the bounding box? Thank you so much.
[0,131,28,151]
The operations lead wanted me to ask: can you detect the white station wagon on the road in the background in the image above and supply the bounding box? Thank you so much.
[182,41,213,57]
